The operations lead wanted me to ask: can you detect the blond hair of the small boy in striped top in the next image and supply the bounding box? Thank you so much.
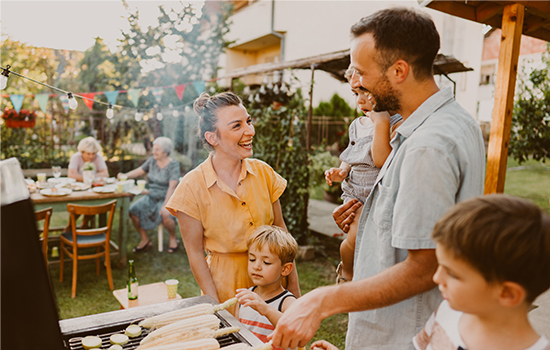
[247,225,298,264]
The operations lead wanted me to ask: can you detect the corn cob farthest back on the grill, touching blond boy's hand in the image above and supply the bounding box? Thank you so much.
[140,297,237,329]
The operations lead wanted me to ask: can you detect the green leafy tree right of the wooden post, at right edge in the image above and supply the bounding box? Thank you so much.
[509,45,550,164]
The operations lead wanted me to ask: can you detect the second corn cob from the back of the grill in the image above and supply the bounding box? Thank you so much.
[140,314,220,345]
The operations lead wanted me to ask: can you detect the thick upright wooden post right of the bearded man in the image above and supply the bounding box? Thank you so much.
[484,4,524,194]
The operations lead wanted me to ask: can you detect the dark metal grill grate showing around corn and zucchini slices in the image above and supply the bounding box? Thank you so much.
[66,313,251,350]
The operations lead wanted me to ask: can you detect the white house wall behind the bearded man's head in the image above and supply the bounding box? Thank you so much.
[219,0,483,120]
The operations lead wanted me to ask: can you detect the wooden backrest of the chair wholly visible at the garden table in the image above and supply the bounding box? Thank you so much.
[67,200,117,243]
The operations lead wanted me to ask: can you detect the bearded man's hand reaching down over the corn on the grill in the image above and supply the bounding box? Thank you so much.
[268,288,324,350]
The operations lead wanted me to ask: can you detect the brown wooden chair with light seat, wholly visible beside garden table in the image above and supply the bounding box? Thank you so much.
[59,200,117,298]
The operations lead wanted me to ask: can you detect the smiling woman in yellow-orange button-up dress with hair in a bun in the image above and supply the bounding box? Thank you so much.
[166,92,300,313]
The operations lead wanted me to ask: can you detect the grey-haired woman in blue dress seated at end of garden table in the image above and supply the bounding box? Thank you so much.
[117,137,180,253]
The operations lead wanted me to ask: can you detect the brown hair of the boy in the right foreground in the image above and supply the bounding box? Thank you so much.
[432,194,549,303]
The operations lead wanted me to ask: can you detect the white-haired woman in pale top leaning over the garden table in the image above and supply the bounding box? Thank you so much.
[67,137,109,182]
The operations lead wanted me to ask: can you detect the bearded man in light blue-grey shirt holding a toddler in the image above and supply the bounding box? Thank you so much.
[272,8,485,349]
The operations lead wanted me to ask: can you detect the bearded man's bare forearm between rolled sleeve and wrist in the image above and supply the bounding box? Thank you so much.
[316,250,438,318]
